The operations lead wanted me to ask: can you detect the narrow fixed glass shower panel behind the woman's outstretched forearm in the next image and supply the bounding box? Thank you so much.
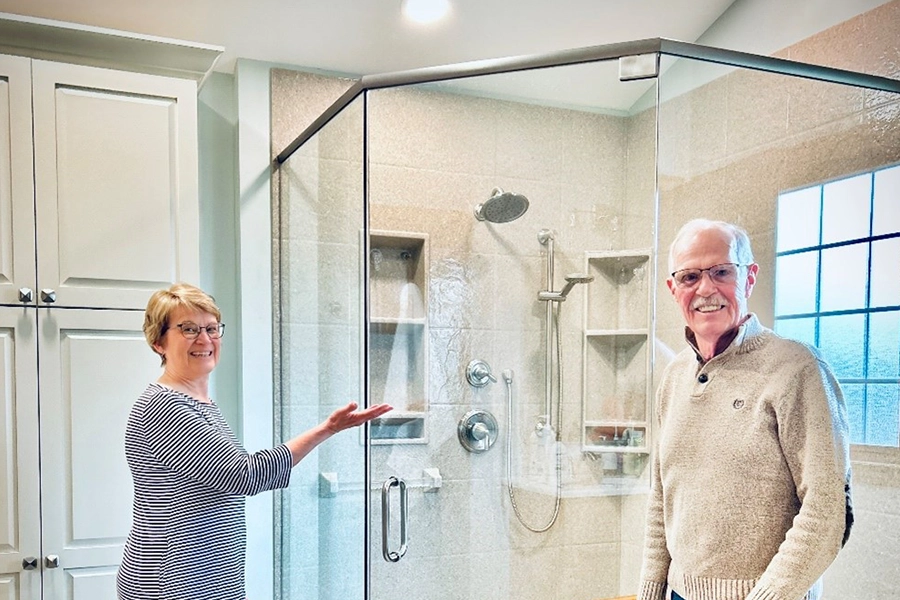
[272,95,364,600]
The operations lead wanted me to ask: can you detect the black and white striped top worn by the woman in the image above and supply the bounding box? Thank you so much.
[116,383,291,600]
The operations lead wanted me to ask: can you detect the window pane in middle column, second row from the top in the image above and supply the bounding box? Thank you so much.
[819,244,869,312]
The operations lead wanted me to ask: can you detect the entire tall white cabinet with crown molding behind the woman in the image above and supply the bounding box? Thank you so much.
[0,15,221,600]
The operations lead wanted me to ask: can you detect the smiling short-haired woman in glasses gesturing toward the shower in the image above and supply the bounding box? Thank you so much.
[117,284,391,600]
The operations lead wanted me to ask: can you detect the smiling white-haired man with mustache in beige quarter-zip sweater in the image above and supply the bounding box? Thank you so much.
[638,220,852,600]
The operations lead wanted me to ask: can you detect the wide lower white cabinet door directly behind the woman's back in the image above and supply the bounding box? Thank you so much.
[37,308,161,600]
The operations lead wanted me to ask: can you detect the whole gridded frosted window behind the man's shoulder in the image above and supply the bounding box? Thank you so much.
[775,165,900,447]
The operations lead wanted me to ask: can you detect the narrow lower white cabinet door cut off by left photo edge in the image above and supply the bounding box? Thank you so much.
[0,308,41,600]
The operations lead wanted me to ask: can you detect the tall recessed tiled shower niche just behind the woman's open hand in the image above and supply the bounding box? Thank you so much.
[369,231,428,444]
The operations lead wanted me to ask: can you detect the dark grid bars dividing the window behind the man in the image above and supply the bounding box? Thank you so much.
[775,166,900,446]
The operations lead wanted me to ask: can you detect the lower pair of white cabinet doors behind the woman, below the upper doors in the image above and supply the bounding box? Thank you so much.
[0,307,159,600]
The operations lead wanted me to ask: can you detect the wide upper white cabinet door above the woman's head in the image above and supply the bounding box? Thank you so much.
[32,60,199,309]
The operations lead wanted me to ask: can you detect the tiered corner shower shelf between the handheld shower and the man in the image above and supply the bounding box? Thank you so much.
[581,249,653,468]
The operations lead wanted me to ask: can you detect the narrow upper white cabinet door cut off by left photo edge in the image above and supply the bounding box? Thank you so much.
[0,55,35,304]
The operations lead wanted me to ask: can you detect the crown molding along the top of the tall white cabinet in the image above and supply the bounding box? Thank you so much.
[0,12,225,84]
